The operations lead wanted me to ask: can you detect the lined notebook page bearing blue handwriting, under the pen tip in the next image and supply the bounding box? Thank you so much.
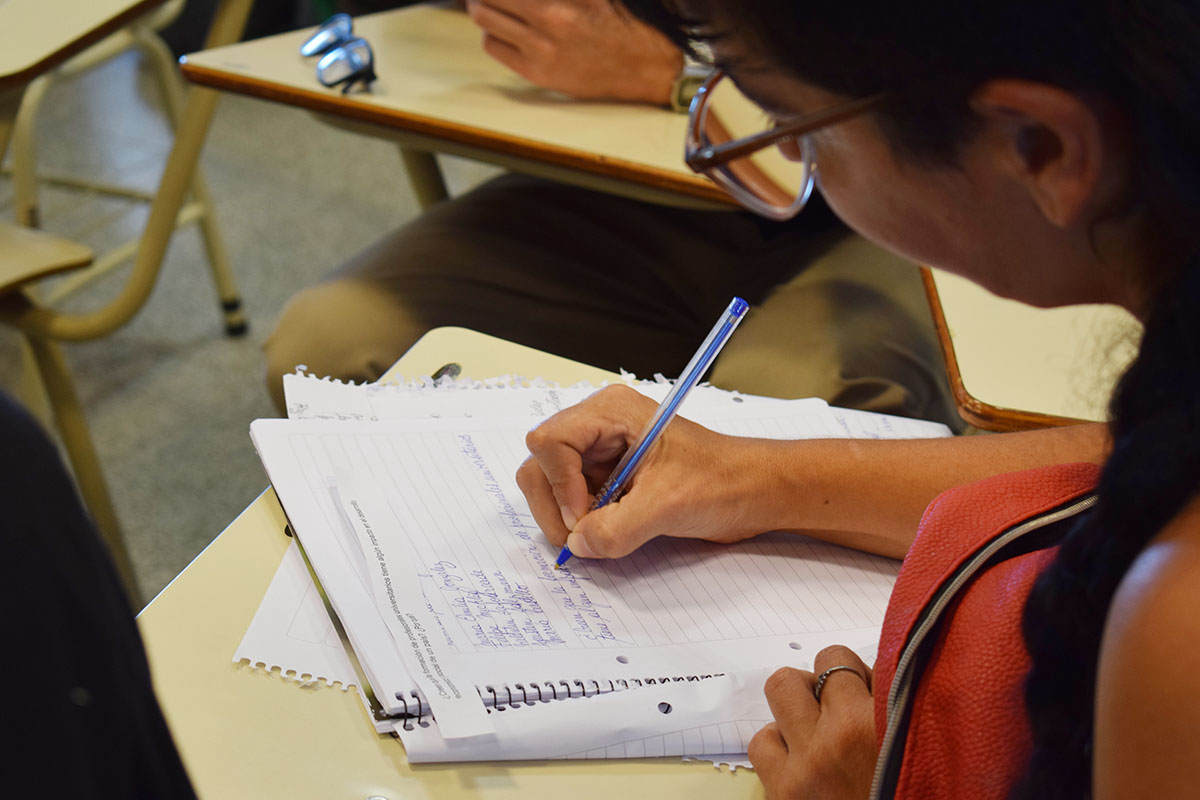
[253,414,896,757]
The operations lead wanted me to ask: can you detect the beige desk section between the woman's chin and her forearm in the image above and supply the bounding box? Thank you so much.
[926,271,1141,431]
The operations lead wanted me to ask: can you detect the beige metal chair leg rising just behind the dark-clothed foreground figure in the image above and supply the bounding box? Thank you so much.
[25,336,142,608]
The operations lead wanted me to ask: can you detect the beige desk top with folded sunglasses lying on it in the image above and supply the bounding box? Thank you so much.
[182,6,732,206]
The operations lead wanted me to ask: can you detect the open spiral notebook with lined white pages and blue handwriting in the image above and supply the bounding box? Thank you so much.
[252,376,950,762]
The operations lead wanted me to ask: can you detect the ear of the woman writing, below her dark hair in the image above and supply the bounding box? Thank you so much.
[971,79,1106,228]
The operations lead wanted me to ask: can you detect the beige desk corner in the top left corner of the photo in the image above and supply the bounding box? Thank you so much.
[0,0,164,88]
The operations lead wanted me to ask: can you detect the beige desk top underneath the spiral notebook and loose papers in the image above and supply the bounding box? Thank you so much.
[138,329,762,800]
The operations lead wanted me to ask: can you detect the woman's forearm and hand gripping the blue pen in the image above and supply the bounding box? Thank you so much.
[517,386,1108,558]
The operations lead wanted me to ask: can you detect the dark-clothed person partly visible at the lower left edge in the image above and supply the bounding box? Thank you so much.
[0,395,196,800]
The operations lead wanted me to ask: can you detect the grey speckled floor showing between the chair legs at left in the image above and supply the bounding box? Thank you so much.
[0,47,494,597]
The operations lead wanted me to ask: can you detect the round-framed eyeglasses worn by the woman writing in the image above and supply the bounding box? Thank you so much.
[684,71,883,219]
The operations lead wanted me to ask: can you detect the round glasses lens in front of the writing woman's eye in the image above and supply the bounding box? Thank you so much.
[692,78,812,219]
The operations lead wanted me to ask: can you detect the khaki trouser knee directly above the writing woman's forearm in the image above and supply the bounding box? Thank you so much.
[710,235,961,428]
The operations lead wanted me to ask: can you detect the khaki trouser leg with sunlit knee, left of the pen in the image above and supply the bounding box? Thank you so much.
[265,175,821,411]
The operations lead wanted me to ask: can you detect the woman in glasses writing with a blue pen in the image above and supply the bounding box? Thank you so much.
[517,0,1200,798]
